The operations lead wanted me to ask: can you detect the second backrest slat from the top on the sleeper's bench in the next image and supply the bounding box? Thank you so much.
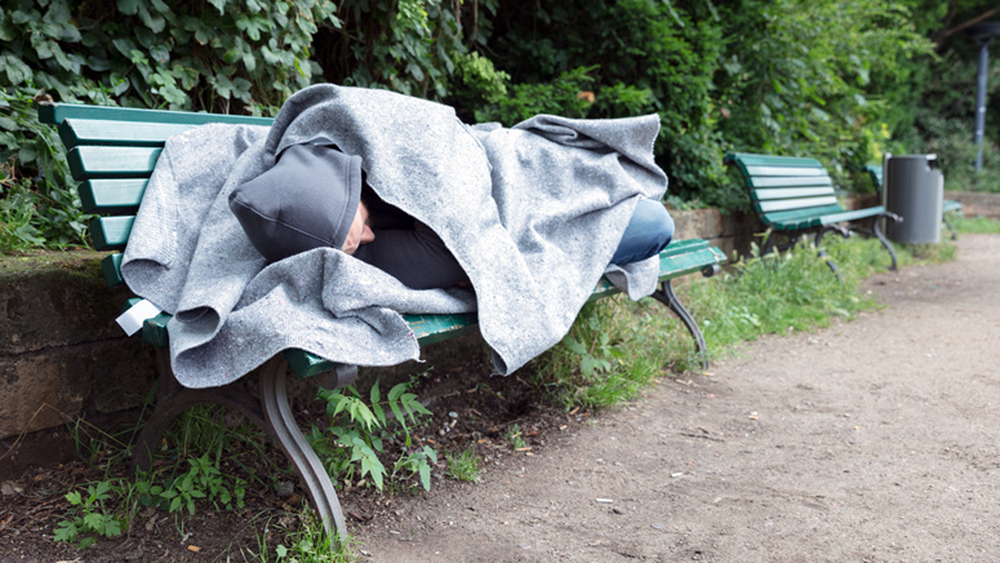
[59,118,196,149]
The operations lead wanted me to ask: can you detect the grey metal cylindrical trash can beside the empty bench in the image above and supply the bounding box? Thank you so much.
[882,154,944,244]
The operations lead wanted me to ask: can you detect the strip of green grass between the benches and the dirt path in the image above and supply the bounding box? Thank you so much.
[529,232,955,411]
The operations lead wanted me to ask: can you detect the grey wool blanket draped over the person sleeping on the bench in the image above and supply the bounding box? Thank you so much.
[122,85,667,388]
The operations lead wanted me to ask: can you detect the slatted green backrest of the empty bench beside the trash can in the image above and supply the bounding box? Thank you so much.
[726,153,844,226]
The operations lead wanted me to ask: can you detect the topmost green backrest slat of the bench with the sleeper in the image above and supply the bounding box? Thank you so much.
[38,103,274,126]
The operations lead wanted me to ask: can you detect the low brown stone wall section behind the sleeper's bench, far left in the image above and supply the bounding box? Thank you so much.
[0,251,155,438]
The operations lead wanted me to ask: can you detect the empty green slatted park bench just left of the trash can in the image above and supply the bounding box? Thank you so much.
[725,153,902,275]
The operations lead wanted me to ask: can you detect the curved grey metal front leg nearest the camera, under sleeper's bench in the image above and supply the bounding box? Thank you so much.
[260,354,347,539]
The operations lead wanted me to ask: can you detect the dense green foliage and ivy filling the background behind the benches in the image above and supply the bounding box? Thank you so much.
[0,0,1000,250]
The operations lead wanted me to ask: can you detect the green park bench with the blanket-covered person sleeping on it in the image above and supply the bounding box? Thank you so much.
[38,103,725,548]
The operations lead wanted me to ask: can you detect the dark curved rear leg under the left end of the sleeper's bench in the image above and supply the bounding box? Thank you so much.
[132,348,267,473]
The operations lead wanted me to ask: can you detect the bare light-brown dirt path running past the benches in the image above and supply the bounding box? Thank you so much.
[353,235,1000,563]
